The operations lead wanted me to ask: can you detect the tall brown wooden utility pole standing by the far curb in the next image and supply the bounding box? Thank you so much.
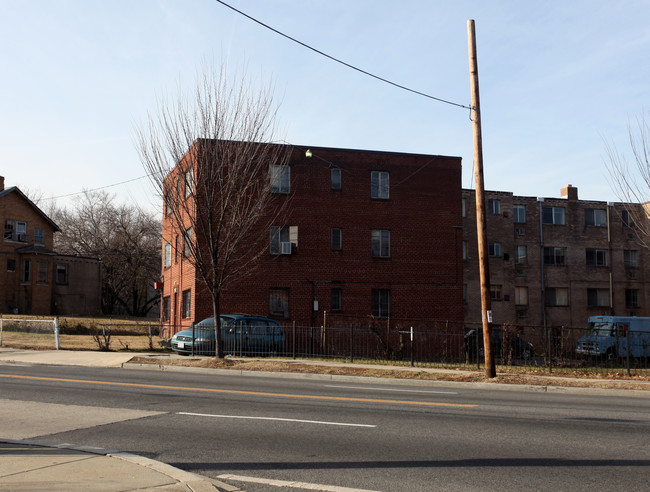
[467,19,497,378]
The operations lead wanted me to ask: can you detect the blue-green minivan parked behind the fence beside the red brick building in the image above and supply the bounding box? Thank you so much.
[171,314,285,356]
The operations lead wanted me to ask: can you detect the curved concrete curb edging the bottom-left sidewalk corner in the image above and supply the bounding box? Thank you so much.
[0,438,243,492]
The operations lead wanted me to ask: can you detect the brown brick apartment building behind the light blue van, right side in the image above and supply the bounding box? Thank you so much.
[463,185,650,328]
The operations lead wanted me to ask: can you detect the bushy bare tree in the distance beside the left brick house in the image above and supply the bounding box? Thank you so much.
[53,191,161,316]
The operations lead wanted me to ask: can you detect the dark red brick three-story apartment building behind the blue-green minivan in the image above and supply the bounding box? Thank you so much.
[161,140,463,335]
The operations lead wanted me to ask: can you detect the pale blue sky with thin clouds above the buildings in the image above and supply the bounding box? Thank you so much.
[0,0,650,213]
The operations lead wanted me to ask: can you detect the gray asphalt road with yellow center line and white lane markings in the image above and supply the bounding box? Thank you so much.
[0,364,650,492]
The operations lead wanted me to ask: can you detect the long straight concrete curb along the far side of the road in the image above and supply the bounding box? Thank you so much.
[122,362,650,398]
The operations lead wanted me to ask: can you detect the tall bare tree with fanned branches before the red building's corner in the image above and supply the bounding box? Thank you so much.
[137,66,288,358]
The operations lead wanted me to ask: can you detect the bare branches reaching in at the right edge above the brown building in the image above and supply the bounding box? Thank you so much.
[605,113,650,250]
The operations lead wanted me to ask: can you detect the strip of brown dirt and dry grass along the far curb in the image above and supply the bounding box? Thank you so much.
[131,356,650,391]
